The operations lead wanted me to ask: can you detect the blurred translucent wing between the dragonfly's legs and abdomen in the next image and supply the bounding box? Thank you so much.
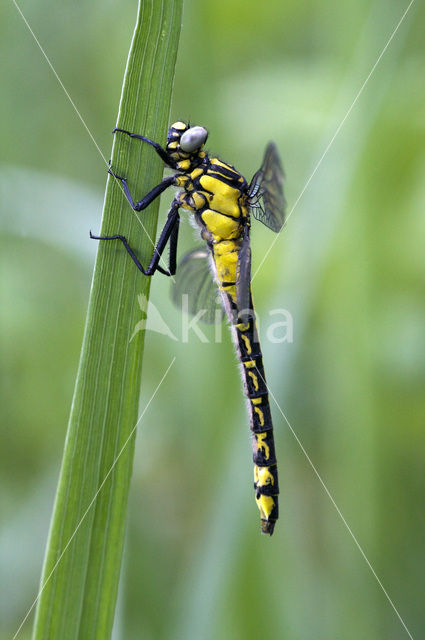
[171,247,224,324]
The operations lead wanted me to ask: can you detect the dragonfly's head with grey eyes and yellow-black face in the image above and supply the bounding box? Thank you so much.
[166,122,208,171]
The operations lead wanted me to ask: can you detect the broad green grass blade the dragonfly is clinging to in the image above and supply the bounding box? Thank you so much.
[29,0,182,640]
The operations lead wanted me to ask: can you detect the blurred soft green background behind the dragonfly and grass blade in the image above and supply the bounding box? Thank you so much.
[0,0,425,640]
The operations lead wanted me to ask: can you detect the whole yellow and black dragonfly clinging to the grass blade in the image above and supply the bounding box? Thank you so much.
[90,121,285,535]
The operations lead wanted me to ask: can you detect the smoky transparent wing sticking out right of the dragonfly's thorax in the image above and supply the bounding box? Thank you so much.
[248,142,286,233]
